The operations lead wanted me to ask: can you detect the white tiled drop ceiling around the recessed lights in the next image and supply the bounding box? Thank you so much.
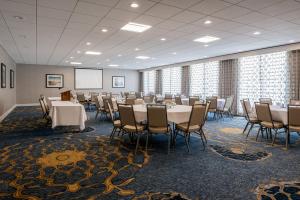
[0,0,300,69]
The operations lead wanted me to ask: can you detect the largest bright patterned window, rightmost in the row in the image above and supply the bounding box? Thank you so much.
[238,51,289,113]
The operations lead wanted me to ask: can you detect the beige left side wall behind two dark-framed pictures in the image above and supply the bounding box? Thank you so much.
[0,45,17,121]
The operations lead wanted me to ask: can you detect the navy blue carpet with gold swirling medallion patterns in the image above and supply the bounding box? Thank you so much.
[0,107,300,200]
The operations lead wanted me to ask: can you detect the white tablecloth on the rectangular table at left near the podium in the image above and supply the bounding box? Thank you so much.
[49,101,87,130]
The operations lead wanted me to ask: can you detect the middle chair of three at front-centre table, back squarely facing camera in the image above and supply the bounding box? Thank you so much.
[146,104,172,154]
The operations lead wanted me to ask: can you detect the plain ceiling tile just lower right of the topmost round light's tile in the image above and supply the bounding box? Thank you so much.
[146,4,181,18]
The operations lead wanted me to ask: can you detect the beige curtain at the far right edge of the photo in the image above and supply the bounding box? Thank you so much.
[288,50,300,99]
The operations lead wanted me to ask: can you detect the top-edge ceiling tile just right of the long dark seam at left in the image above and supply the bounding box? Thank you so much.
[38,0,77,11]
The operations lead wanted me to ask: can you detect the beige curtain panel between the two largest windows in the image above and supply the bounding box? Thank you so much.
[219,59,238,114]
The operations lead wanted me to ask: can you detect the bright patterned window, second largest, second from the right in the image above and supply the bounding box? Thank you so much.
[190,61,219,98]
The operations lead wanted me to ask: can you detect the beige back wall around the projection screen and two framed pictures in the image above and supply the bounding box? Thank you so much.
[17,64,139,104]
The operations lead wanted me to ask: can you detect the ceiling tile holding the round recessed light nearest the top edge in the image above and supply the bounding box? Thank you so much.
[116,0,155,13]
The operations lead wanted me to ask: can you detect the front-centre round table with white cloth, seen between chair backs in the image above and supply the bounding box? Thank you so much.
[133,105,192,124]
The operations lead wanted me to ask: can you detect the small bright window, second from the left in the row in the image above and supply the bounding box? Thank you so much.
[162,67,182,94]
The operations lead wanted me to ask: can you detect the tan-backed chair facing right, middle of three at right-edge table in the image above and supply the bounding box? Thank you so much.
[255,103,284,145]
